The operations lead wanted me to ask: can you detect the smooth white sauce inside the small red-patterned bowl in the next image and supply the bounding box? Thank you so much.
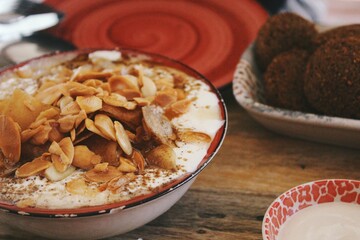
[277,202,360,240]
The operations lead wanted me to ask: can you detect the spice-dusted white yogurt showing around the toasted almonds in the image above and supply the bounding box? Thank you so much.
[0,51,224,209]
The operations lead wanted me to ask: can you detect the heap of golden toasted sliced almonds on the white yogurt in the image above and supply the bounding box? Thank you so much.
[0,49,217,203]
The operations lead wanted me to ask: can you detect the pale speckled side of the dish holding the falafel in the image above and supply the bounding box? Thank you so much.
[233,44,360,148]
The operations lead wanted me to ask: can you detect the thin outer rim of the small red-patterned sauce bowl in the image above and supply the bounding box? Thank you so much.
[261,178,360,240]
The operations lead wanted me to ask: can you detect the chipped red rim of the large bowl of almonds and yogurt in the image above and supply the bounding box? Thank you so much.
[0,49,227,218]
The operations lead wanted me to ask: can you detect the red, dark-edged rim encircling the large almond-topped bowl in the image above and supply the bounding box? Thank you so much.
[0,47,228,218]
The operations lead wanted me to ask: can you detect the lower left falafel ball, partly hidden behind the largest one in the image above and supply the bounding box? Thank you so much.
[264,49,310,111]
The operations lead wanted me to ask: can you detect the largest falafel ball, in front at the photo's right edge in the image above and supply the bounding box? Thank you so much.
[304,38,360,118]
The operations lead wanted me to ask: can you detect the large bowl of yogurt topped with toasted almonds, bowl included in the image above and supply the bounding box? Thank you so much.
[0,49,227,239]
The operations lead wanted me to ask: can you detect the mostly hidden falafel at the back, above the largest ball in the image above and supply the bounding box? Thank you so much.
[315,24,360,47]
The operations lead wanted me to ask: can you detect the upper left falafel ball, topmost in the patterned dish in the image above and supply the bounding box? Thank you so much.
[255,13,317,70]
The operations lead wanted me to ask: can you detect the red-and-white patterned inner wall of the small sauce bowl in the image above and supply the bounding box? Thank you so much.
[262,179,360,240]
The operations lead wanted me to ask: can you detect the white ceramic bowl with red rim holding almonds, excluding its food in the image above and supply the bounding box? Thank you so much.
[0,49,227,239]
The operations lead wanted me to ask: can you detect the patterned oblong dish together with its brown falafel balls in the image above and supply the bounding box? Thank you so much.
[233,13,360,148]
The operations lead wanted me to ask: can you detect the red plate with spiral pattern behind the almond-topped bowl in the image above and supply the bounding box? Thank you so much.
[46,0,267,87]
